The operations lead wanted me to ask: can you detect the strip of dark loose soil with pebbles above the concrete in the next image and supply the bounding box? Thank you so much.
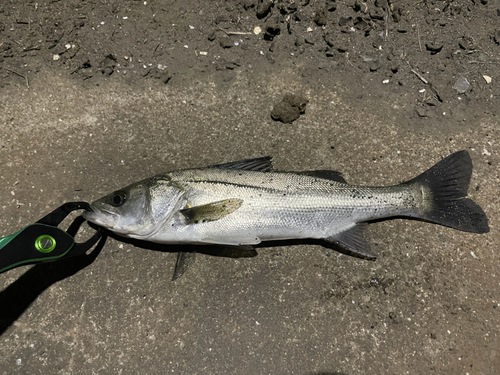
[0,0,500,128]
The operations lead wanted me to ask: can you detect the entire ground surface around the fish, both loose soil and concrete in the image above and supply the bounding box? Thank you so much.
[0,0,500,374]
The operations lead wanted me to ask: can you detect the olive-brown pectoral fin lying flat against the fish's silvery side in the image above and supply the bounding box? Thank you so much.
[180,198,243,224]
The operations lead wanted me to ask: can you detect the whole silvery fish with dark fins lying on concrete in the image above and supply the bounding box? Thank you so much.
[83,150,489,278]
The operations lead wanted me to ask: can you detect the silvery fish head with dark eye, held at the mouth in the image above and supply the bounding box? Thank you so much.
[83,176,184,240]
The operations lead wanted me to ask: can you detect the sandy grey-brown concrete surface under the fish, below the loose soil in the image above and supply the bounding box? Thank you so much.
[0,1,500,374]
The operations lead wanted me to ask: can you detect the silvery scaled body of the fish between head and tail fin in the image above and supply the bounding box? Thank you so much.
[165,169,415,244]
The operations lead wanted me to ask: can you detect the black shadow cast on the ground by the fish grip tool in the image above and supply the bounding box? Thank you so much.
[0,216,106,336]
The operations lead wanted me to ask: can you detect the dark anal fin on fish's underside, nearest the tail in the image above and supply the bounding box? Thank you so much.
[325,223,377,260]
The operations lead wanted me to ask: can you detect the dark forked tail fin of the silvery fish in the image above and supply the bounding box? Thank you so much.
[406,150,490,233]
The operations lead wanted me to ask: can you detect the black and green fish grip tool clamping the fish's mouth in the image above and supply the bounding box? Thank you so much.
[0,202,104,273]
